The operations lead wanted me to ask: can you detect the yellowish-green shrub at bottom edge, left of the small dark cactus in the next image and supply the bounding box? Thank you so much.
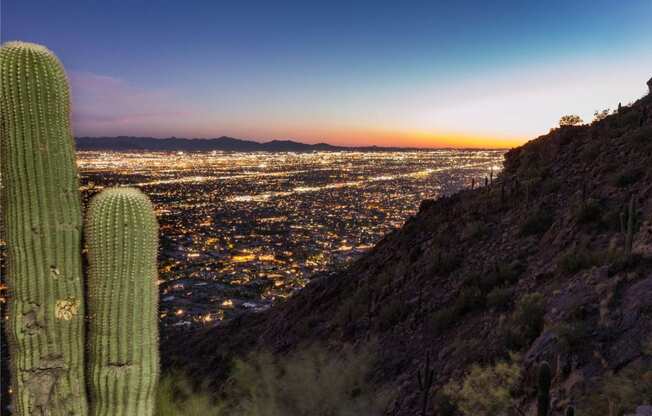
[444,358,521,416]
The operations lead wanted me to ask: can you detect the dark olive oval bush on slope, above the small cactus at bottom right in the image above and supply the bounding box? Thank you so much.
[503,293,546,350]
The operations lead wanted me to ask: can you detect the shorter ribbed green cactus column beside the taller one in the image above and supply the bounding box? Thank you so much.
[86,188,159,416]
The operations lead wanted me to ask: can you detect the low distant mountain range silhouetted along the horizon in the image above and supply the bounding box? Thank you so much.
[76,136,414,152]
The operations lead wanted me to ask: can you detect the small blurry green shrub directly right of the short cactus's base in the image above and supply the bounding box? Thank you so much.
[156,373,226,416]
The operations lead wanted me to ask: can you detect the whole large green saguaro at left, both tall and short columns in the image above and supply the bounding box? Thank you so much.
[0,42,159,416]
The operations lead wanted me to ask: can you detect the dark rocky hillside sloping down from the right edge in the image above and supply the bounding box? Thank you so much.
[163,91,652,415]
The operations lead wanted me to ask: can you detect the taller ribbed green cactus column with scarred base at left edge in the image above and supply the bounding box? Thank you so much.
[0,42,88,416]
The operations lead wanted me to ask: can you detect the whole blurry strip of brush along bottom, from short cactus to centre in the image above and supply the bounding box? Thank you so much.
[156,345,384,416]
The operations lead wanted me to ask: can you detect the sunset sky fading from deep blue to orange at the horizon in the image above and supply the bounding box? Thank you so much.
[0,0,652,147]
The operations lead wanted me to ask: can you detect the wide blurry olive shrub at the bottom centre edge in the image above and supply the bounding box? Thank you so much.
[226,347,389,416]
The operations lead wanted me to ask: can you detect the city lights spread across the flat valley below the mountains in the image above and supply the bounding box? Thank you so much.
[0,150,504,327]
